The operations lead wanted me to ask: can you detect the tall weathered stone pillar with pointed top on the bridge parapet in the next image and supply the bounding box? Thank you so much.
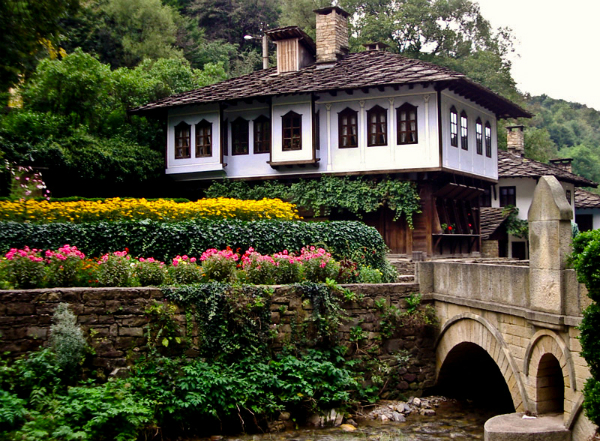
[527,176,573,314]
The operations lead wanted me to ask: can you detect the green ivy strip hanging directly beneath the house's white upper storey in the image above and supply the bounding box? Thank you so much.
[206,176,421,228]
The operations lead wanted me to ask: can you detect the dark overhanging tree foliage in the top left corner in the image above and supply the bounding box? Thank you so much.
[0,0,79,101]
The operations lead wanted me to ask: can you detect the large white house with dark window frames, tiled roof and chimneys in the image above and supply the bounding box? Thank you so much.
[132,7,530,255]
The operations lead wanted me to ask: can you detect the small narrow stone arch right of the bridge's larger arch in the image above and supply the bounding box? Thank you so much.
[523,329,577,414]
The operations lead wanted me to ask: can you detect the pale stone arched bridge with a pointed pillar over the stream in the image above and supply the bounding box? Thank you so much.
[417,177,595,440]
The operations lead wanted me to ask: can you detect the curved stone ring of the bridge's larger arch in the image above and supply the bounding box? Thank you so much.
[435,313,531,412]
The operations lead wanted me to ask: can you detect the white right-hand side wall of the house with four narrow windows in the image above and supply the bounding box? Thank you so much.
[441,91,498,179]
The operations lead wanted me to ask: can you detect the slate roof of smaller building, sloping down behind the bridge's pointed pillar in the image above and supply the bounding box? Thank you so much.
[498,150,598,187]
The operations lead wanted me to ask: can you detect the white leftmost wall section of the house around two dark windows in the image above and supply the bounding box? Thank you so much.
[165,105,222,174]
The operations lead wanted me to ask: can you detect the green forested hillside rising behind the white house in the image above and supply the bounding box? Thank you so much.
[0,0,600,196]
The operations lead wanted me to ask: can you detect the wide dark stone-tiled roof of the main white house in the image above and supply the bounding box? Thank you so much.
[131,51,531,118]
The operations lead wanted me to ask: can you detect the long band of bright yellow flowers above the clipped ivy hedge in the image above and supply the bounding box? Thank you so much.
[0,198,299,223]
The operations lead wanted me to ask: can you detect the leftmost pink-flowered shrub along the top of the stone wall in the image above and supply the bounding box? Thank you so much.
[5,247,46,288]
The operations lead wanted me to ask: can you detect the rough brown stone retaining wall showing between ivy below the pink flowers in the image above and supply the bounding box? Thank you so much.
[0,283,435,395]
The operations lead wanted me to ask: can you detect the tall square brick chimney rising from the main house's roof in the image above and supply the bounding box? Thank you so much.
[314,6,350,64]
